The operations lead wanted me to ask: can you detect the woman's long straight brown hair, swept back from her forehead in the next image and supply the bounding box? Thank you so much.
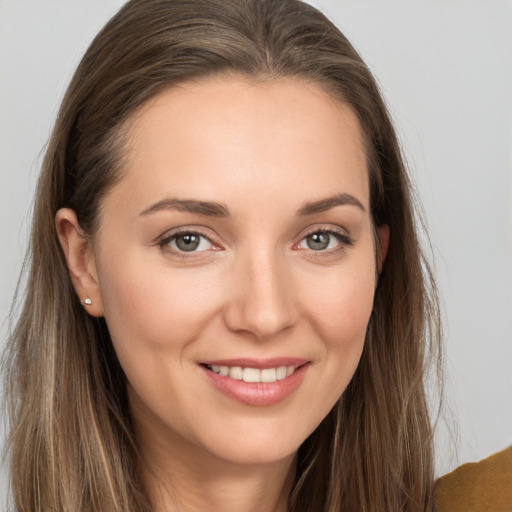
[4,0,440,512]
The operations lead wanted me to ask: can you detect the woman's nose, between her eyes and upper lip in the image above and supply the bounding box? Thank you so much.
[224,251,298,339]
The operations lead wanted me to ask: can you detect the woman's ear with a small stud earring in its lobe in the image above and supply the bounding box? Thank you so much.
[55,208,103,317]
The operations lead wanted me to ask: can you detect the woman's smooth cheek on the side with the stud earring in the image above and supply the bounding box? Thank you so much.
[100,254,221,363]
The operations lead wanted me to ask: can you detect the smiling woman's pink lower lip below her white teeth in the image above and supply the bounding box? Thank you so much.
[201,363,309,407]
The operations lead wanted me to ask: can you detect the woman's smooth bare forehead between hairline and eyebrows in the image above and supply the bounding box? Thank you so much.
[108,76,369,218]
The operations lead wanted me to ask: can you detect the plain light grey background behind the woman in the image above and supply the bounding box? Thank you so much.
[0,0,512,496]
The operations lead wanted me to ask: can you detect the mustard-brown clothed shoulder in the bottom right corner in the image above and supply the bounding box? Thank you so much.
[436,446,512,512]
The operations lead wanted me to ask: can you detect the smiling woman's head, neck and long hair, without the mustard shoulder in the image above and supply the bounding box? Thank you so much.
[2,0,439,512]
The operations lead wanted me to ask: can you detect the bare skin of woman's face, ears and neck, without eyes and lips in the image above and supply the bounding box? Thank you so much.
[56,76,389,512]
